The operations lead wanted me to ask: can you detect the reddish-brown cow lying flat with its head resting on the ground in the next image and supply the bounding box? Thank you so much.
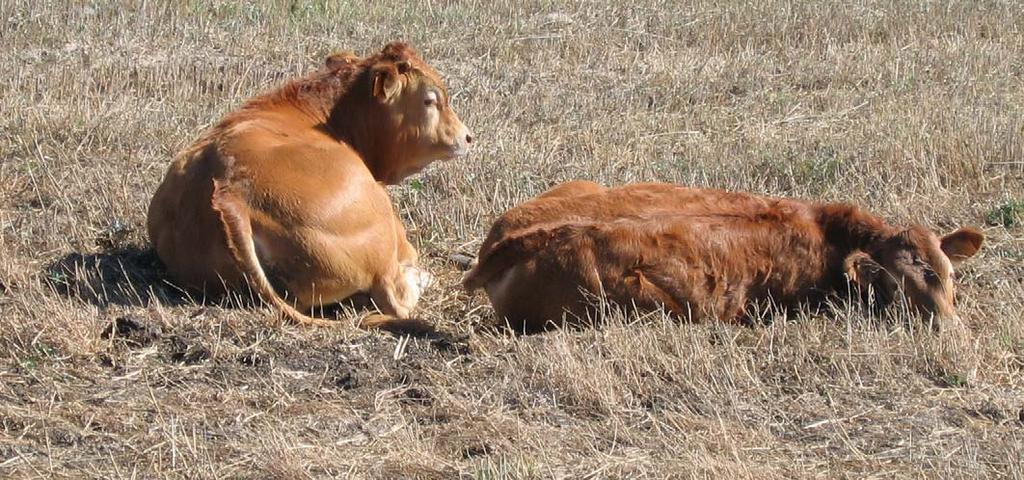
[463,181,984,332]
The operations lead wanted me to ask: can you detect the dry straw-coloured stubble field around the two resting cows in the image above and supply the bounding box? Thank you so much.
[0,0,1024,479]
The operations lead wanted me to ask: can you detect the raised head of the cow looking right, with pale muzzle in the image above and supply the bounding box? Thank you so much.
[364,43,473,183]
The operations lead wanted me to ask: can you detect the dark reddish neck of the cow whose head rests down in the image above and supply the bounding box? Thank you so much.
[816,204,897,255]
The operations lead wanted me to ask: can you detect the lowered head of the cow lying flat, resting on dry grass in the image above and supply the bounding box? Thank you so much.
[844,226,985,328]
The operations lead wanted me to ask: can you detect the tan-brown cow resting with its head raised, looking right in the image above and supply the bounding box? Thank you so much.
[147,43,473,328]
